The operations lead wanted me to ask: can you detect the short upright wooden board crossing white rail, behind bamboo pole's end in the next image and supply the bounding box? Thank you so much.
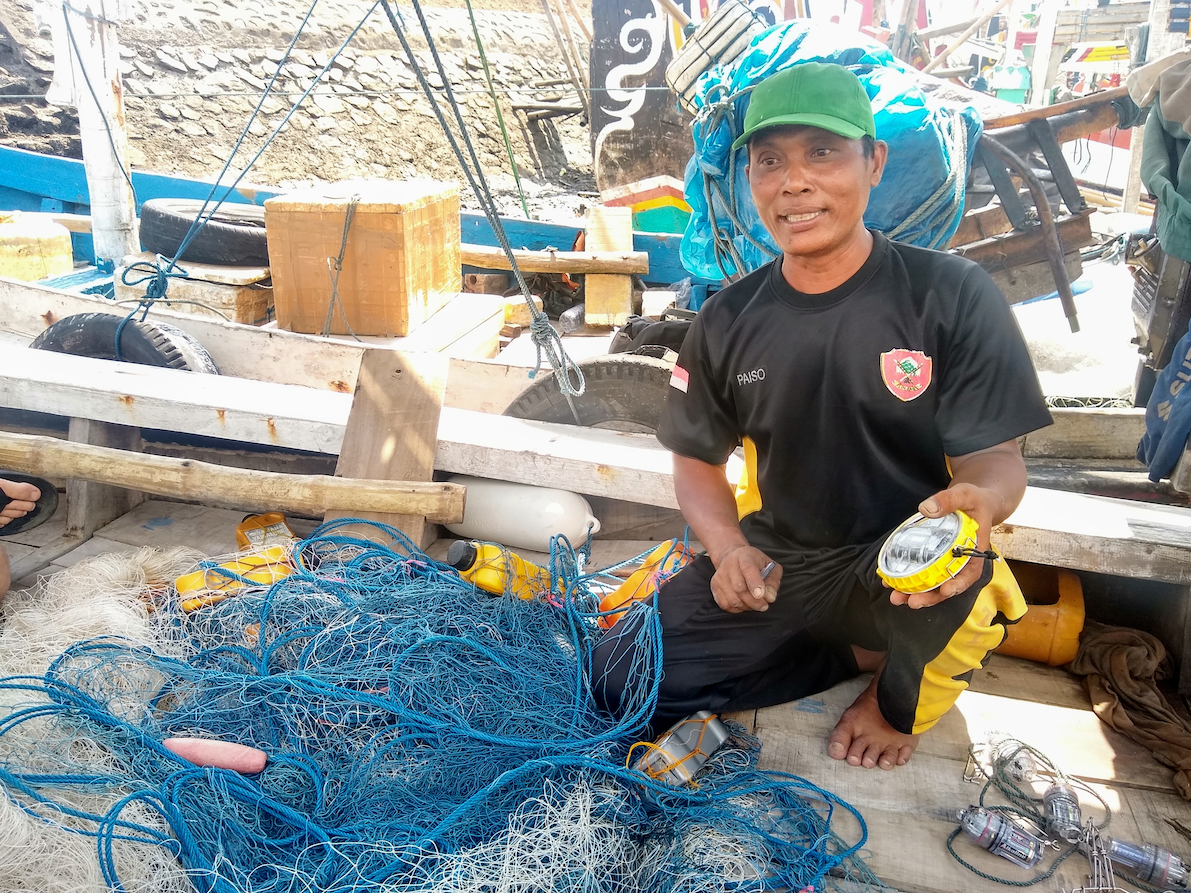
[325,352,447,548]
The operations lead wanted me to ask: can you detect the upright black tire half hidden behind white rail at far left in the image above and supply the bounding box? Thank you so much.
[30,313,219,375]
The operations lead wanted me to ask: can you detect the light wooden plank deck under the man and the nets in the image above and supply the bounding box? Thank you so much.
[0,500,1191,893]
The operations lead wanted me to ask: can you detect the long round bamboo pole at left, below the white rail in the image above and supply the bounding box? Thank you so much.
[0,432,463,523]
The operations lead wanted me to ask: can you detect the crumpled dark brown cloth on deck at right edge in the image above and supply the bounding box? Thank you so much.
[1067,622,1191,800]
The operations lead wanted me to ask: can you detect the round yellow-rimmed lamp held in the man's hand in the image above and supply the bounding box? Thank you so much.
[877,512,977,593]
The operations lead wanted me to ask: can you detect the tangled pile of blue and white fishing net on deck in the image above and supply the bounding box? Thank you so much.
[0,522,880,893]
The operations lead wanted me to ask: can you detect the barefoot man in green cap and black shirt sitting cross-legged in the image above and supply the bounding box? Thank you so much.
[593,62,1050,769]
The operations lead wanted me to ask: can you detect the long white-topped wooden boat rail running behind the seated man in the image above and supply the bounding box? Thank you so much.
[0,349,1191,583]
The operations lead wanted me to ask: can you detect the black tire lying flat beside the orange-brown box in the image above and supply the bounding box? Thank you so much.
[141,199,269,267]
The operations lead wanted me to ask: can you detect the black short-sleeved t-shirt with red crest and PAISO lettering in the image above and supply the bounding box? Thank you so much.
[657,232,1050,548]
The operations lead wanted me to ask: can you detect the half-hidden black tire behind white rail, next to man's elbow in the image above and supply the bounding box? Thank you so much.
[504,354,674,435]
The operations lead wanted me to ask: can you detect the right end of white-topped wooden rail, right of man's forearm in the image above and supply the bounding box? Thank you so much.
[992,487,1191,583]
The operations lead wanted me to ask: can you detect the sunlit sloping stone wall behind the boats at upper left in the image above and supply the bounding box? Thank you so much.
[0,0,592,215]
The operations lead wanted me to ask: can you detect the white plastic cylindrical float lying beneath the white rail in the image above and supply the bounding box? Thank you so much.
[445,475,599,552]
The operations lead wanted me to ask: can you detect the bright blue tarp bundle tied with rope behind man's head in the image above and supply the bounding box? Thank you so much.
[681,19,983,279]
